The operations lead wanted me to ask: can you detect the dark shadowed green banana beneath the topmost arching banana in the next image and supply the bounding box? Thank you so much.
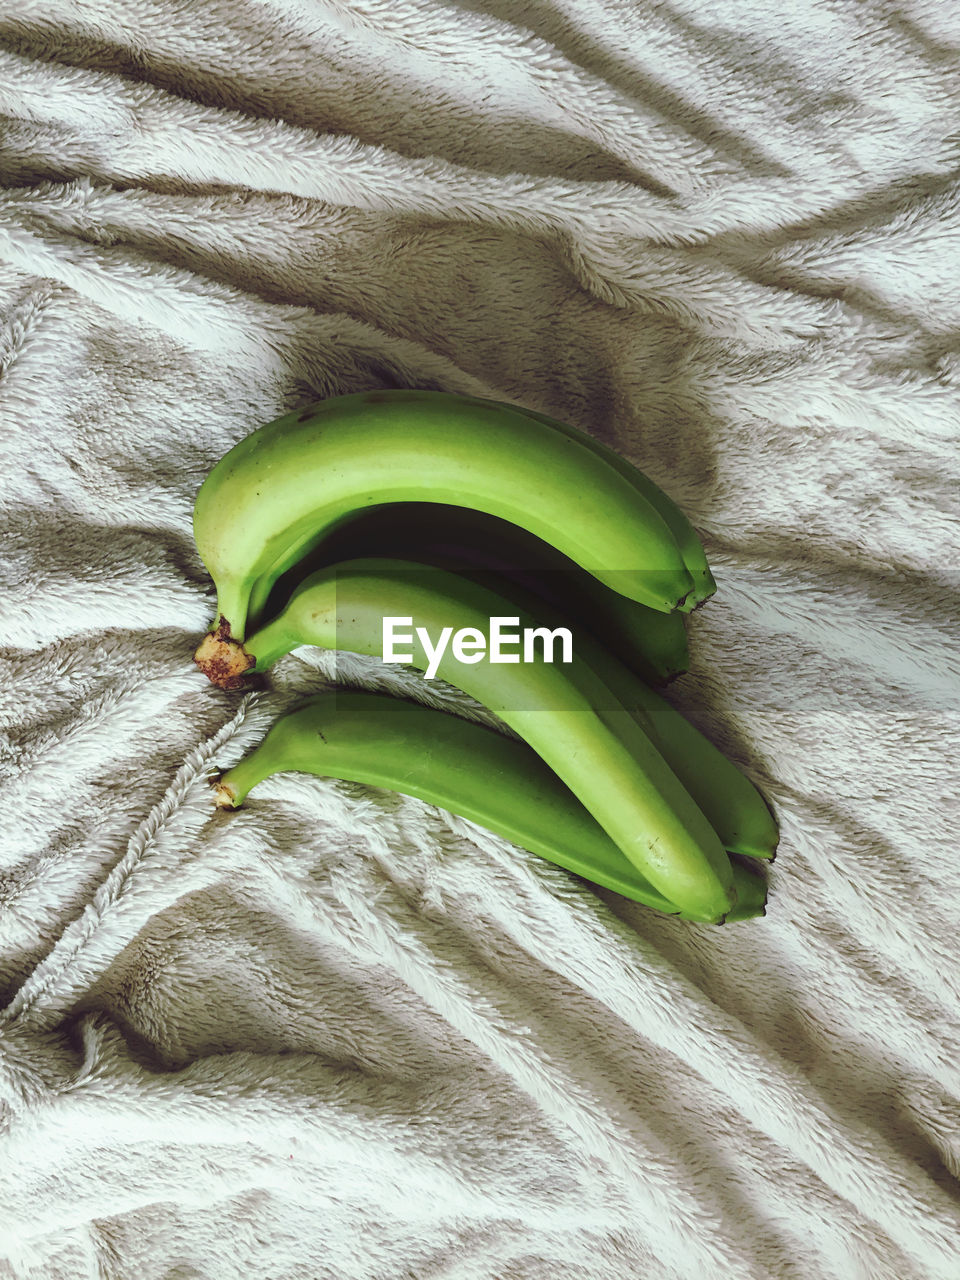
[251,502,690,684]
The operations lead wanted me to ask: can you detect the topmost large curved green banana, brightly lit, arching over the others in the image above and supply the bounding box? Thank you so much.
[193,389,694,640]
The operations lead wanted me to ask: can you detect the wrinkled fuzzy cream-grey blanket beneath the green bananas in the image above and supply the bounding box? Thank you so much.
[0,0,960,1280]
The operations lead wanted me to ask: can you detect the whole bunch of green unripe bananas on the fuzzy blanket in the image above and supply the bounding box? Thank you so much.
[193,390,778,923]
